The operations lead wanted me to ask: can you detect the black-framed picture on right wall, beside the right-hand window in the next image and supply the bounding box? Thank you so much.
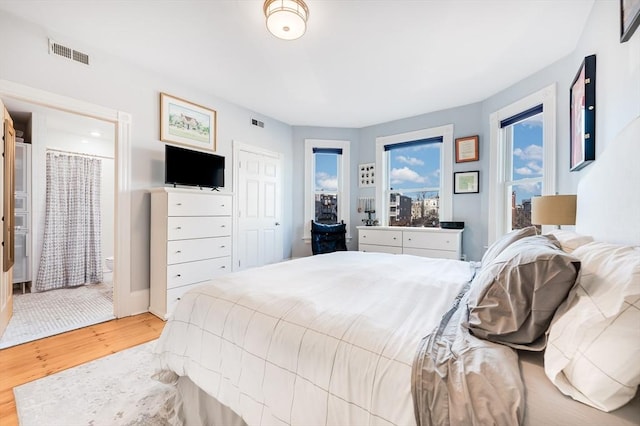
[569,55,596,172]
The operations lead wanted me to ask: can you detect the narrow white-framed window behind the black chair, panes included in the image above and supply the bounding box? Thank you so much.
[304,139,350,239]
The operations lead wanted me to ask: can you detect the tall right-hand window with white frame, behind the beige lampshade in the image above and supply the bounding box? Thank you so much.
[489,85,555,243]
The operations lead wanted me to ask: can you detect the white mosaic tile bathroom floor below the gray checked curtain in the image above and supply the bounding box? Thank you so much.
[0,283,115,349]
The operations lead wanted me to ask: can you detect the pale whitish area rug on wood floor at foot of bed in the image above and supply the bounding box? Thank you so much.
[13,340,175,426]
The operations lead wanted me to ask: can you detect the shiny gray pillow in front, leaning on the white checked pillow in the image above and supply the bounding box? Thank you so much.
[467,235,580,350]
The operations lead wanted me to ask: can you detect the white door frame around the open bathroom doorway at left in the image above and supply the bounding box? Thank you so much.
[0,80,135,318]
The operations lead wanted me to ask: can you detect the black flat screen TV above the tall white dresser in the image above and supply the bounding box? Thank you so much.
[164,145,224,189]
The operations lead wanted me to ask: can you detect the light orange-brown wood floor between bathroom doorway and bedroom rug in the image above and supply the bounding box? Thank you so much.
[0,313,165,426]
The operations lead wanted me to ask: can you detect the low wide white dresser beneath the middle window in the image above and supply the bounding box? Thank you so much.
[358,226,464,260]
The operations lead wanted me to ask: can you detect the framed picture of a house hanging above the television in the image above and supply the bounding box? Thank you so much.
[160,93,216,151]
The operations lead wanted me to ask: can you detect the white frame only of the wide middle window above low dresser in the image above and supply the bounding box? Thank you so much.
[376,124,453,226]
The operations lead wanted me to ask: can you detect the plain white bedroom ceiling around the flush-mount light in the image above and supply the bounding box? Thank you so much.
[0,0,594,128]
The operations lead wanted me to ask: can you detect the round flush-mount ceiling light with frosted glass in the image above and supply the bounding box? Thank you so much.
[263,0,309,40]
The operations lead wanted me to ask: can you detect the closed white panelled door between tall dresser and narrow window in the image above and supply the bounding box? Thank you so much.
[234,148,283,270]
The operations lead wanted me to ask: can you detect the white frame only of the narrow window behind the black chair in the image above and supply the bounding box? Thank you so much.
[302,139,351,243]
